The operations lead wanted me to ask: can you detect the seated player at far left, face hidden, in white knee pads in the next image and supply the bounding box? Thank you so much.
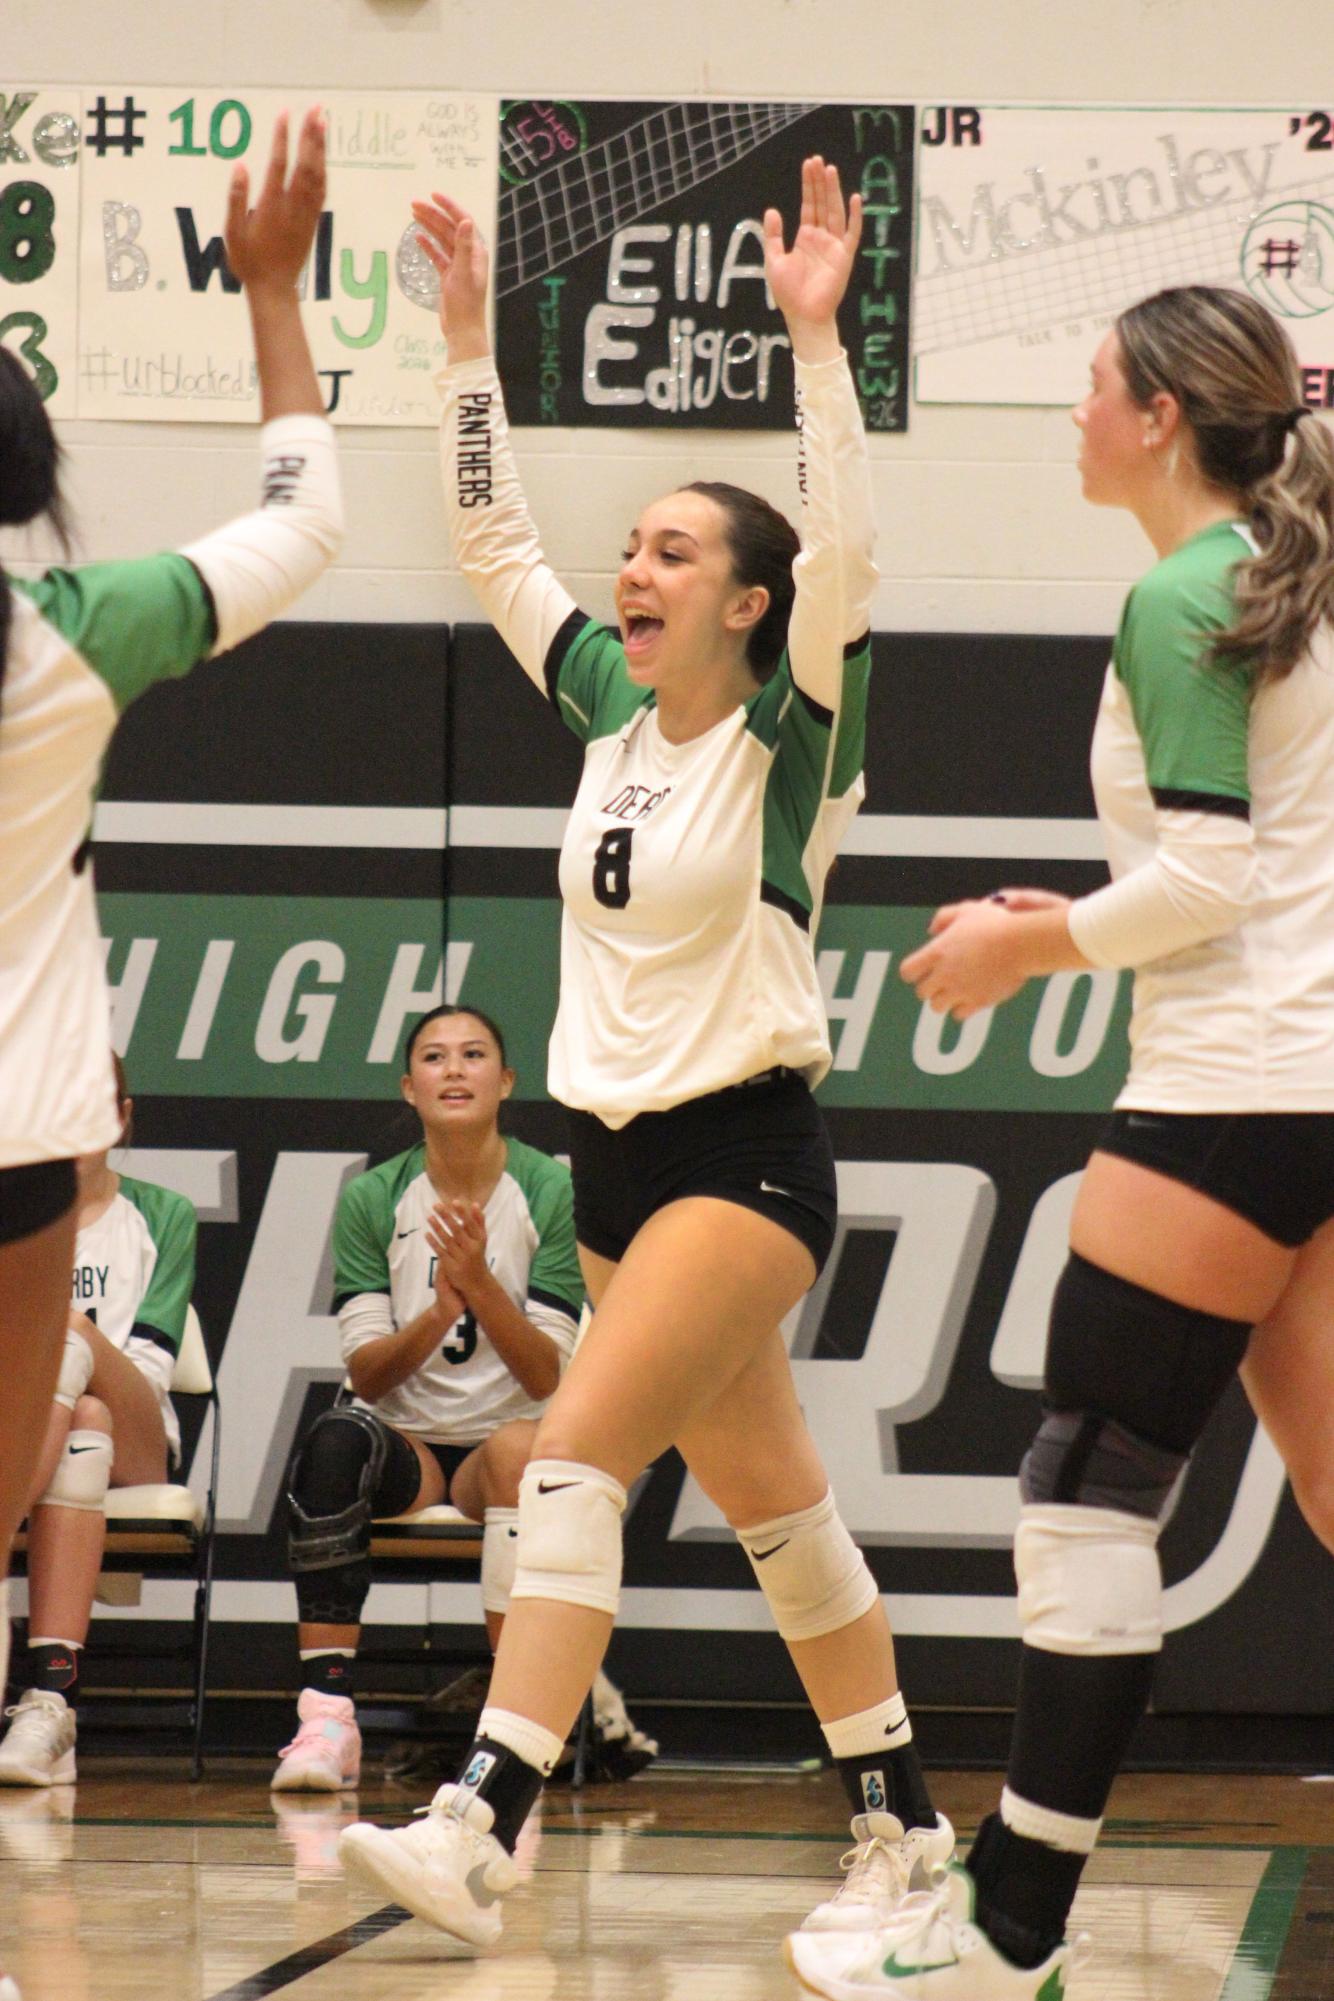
[0,1059,198,1785]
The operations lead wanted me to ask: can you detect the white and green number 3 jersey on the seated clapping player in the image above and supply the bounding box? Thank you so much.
[334,1139,584,1445]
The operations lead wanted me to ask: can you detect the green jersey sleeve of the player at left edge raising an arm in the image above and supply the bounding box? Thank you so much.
[16,554,216,712]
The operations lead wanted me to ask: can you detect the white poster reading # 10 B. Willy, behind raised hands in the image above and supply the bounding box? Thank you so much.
[76,86,498,426]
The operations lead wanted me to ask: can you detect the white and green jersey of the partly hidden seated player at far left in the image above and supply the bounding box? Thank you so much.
[70,1175,198,1459]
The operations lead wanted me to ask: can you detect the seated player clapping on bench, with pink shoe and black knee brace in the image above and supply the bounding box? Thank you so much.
[272,1007,658,1793]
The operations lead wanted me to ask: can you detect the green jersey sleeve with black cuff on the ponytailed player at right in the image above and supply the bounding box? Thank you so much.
[1112,522,1254,818]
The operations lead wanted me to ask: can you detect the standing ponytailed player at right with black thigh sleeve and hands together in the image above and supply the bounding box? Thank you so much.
[790,286,1334,2001]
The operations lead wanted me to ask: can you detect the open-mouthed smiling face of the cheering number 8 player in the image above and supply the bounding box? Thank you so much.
[616,492,768,688]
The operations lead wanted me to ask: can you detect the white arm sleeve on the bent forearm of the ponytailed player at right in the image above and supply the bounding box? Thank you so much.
[1068,806,1256,966]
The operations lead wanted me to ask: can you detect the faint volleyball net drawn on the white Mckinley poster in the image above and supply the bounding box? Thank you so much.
[912,174,1334,358]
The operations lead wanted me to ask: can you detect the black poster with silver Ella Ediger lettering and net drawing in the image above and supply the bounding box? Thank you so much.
[496,100,914,430]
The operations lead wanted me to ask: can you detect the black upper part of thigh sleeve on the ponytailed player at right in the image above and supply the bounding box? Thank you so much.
[1044,1253,1250,1456]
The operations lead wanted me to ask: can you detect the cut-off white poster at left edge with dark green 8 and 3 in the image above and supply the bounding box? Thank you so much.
[0,84,82,416]
